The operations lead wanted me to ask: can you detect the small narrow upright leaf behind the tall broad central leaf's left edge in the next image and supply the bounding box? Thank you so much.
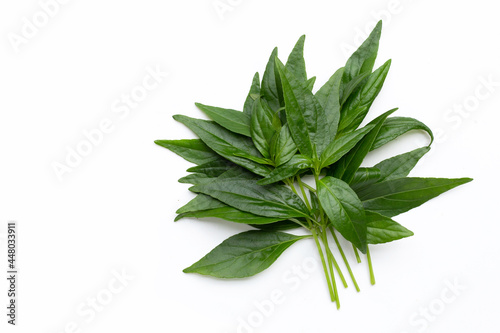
[261,48,283,112]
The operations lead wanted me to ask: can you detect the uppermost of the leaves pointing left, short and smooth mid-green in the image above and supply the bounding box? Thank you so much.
[195,103,250,136]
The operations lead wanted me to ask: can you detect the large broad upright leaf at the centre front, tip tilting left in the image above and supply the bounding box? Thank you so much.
[276,59,332,159]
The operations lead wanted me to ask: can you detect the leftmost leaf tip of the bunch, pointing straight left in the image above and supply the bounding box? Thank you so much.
[155,139,220,164]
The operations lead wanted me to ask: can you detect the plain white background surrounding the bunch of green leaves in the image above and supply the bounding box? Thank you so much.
[0,0,500,333]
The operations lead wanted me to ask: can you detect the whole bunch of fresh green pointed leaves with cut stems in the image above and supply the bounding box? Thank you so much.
[156,22,471,307]
